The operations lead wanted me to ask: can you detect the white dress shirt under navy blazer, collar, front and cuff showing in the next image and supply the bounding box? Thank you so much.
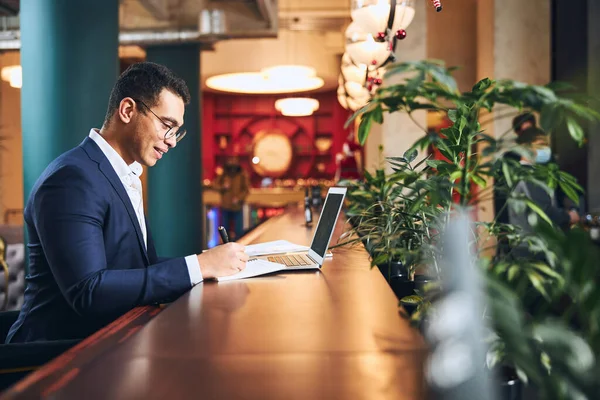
[89,129,203,286]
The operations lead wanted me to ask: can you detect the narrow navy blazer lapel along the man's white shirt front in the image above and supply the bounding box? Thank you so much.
[81,137,150,265]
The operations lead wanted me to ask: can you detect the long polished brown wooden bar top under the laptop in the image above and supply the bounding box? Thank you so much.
[3,207,426,400]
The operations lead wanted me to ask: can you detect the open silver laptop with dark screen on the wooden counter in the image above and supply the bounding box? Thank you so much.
[256,187,346,269]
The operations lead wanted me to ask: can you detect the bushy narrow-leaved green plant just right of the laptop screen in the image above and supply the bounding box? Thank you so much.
[337,146,449,275]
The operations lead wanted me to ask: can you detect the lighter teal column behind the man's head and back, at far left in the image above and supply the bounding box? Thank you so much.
[20,0,119,202]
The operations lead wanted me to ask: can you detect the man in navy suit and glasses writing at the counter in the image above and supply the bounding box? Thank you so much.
[6,63,248,343]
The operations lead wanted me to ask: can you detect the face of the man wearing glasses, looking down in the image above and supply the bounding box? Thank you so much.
[130,89,185,167]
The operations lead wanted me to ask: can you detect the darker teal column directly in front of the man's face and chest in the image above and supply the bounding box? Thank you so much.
[146,44,203,257]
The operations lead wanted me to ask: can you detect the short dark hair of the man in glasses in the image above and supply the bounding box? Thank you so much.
[104,62,190,123]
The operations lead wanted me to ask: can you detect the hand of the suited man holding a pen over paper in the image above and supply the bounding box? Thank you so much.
[198,242,248,279]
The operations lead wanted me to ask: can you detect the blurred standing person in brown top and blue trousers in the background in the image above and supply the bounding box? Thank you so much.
[215,157,250,239]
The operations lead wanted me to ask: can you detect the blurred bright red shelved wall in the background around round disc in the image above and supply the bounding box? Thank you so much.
[202,91,351,185]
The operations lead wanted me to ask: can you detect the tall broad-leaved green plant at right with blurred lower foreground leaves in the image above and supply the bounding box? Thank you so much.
[346,61,600,398]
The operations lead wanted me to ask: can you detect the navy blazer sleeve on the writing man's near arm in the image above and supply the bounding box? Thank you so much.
[33,166,191,316]
